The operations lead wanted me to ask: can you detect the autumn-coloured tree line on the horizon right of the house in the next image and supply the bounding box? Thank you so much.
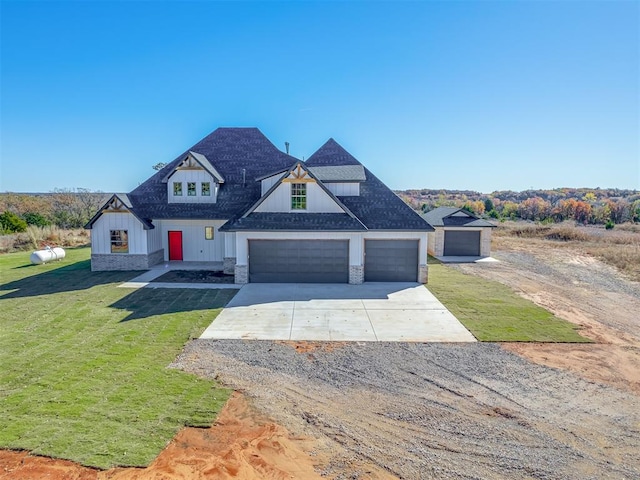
[396,188,640,228]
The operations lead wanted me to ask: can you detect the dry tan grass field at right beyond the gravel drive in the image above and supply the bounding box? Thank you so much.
[494,222,640,281]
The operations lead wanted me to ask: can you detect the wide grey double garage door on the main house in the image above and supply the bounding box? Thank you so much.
[249,240,349,283]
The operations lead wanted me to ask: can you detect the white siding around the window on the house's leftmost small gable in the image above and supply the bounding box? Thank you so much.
[91,212,148,255]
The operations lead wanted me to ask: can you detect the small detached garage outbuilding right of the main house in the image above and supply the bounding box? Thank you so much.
[422,207,496,257]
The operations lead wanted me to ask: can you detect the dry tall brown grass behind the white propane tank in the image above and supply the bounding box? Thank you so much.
[0,225,89,253]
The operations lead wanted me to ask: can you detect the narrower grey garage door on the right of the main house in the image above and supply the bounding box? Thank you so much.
[364,240,419,282]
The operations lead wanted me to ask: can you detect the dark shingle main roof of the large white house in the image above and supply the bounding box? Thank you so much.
[124,128,432,231]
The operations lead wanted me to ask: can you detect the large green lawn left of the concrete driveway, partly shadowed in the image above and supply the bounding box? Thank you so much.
[0,248,236,468]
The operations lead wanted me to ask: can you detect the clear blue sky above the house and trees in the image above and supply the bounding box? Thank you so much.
[0,0,640,193]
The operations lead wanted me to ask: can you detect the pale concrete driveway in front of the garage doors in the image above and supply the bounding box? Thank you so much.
[200,283,476,342]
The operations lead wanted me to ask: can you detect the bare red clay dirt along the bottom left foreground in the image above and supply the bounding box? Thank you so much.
[0,392,323,480]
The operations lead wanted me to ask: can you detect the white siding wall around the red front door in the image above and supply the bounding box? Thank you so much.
[153,220,226,262]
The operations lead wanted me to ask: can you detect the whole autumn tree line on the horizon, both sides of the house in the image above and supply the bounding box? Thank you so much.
[0,188,640,234]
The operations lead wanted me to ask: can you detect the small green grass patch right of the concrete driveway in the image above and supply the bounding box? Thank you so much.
[428,258,591,343]
